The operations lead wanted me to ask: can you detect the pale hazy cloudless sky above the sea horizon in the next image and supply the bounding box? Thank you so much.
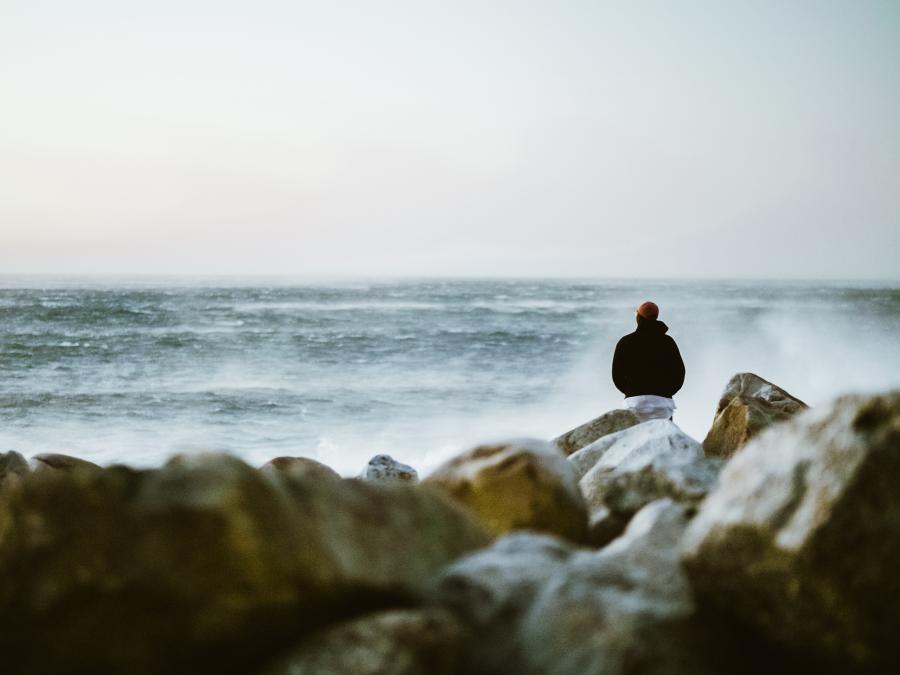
[0,0,900,280]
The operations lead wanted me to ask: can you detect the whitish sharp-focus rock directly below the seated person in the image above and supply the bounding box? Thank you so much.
[569,420,722,546]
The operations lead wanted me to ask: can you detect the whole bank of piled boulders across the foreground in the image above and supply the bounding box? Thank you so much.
[0,373,900,675]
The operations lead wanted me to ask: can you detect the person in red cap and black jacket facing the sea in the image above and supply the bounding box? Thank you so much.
[612,302,684,422]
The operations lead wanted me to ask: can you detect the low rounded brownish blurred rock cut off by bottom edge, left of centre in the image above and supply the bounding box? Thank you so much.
[258,608,463,675]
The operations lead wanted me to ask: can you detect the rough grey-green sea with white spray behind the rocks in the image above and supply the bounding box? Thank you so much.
[0,277,900,476]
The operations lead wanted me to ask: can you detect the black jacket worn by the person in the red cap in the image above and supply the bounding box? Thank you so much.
[613,321,684,398]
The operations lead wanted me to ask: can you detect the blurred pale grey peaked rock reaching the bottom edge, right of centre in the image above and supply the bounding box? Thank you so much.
[517,500,709,675]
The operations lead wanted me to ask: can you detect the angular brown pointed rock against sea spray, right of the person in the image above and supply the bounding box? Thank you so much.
[703,373,808,458]
